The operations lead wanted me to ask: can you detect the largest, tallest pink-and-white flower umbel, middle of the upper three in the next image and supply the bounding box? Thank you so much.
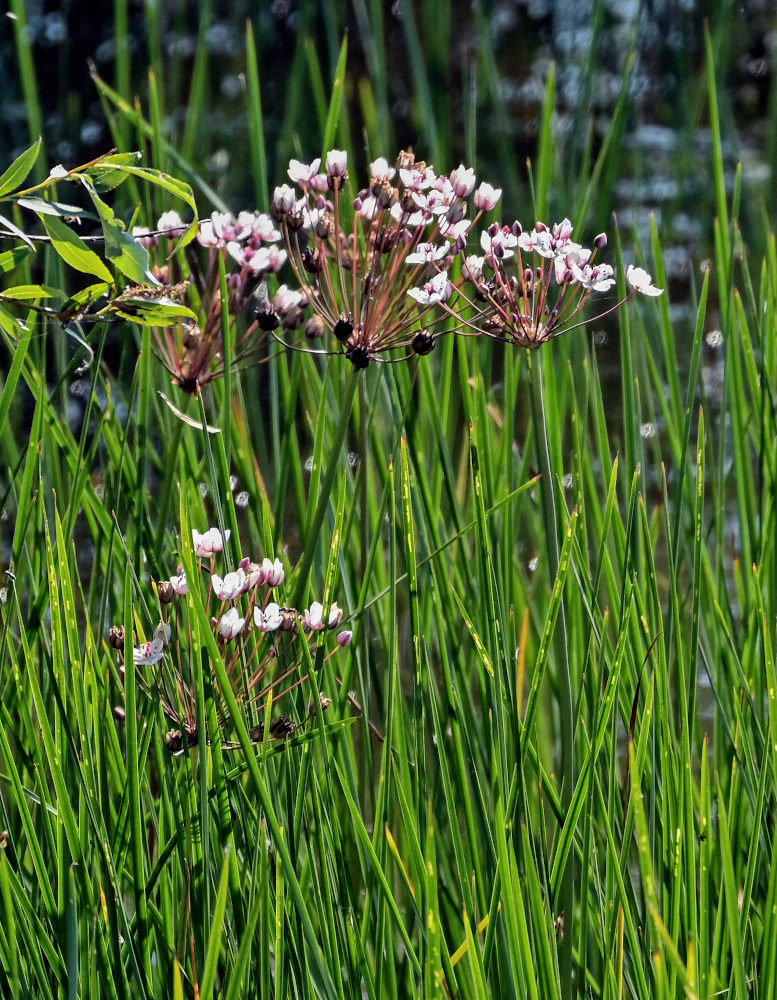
[272,150,501,369]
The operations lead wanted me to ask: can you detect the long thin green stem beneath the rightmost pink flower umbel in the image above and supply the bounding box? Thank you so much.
[529,352,575,997]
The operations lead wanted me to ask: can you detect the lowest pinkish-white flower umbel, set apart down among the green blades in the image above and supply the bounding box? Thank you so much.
[108,528,352,753]
